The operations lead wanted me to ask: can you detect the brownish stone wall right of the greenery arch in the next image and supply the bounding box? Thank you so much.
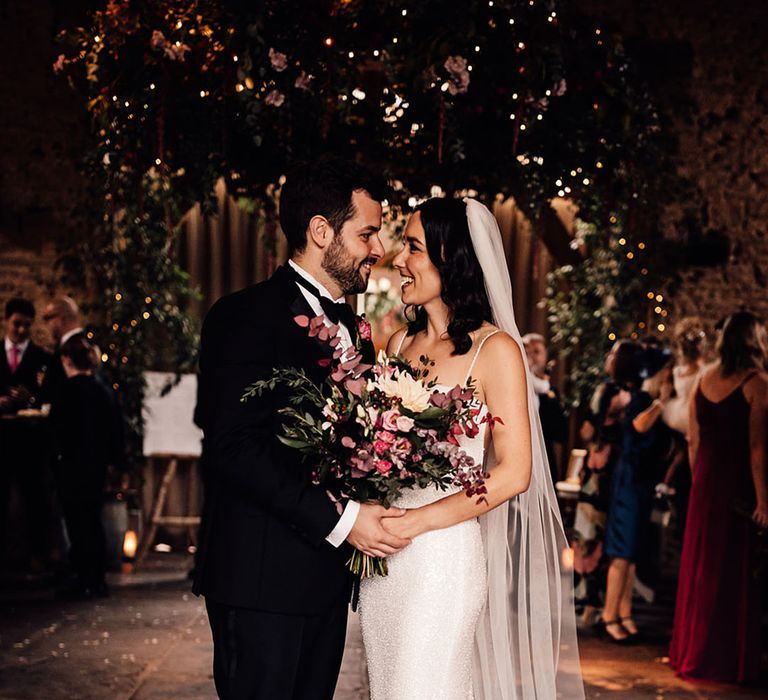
[578,0,768,320]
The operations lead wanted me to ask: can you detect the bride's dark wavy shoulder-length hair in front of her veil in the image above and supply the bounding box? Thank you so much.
[406,197,493,355]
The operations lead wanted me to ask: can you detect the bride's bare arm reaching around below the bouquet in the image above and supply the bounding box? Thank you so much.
[385,333,532,538]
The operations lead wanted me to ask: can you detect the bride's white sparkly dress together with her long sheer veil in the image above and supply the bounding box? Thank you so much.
[360,199,584,700]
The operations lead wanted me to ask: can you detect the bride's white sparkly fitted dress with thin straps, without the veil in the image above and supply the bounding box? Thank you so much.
[359,331,498,700]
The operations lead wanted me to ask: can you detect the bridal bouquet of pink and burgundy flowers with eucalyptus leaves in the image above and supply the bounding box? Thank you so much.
[241,316,498,577]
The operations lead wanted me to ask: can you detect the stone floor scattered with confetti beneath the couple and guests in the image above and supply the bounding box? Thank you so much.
[0,556,768,700]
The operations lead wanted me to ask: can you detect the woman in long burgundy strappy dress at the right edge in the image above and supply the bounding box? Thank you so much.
[669,311,768,683]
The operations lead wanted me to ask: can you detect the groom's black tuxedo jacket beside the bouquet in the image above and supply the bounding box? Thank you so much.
[193,267,373,615]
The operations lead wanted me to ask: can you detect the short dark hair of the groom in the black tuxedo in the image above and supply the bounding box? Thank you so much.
[280,155,389,254]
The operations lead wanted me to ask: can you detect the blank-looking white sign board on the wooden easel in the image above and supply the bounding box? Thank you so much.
[143,372,203,457]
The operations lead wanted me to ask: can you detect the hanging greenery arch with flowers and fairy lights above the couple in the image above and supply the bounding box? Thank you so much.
[54,0,660,448]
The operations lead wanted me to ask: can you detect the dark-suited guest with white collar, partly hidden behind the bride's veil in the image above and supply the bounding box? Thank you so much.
[523,333,568,483]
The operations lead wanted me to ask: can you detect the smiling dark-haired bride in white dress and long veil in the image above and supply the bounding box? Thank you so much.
[359,199,584,700]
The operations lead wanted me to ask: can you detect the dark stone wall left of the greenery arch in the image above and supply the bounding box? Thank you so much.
[0,0,88,344]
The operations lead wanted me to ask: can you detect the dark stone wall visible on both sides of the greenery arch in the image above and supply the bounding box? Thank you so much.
[0,0,768,340]
